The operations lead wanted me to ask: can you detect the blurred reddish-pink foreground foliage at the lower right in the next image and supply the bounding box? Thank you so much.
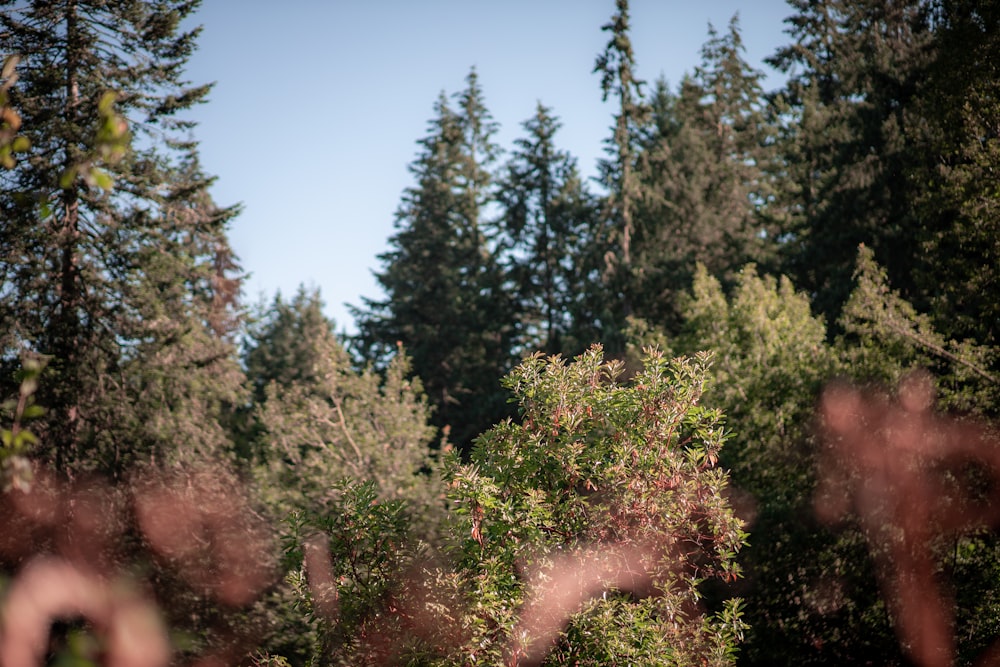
[816,371,1000,667]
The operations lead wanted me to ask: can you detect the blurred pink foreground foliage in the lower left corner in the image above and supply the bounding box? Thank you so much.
[0,468,275,667]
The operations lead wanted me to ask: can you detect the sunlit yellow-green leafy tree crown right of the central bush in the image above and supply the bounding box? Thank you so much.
[675,265,838,510]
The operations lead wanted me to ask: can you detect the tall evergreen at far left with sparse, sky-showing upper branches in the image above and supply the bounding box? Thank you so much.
[0,0,241,472]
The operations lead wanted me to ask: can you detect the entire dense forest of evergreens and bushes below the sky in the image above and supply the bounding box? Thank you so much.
[0,0,1000,667]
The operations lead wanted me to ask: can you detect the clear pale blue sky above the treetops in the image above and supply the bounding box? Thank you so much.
[187,0,792,332]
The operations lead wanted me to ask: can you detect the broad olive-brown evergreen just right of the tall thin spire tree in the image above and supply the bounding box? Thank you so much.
[635,16,775,330]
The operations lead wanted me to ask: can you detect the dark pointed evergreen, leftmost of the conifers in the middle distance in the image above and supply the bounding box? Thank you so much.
[354,70,514,452]
